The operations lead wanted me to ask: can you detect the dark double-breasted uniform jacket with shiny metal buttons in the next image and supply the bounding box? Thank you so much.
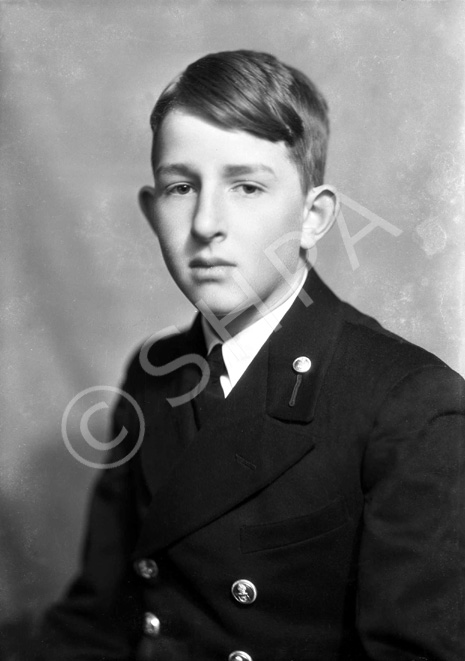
[41,271,465,661]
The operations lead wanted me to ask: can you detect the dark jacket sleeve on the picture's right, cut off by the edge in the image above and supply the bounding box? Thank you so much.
[357,366,465,661]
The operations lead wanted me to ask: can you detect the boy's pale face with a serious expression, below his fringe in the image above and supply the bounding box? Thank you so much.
[141,110,307,330]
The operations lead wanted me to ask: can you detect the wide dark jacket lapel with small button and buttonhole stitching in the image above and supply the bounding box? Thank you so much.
[135,273,340,557]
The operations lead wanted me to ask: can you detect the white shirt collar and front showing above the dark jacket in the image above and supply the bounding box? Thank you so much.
[202,269,308,397]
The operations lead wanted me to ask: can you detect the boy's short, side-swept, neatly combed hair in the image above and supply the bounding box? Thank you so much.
[150,50,329,190]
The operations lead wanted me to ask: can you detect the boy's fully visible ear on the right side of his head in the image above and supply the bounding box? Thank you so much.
[300,185,339,250]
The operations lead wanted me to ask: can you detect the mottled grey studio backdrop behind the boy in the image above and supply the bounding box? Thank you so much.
[0,0,465,640]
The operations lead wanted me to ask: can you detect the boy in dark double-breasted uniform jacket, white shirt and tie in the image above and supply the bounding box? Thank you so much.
[42,51,465,661]
